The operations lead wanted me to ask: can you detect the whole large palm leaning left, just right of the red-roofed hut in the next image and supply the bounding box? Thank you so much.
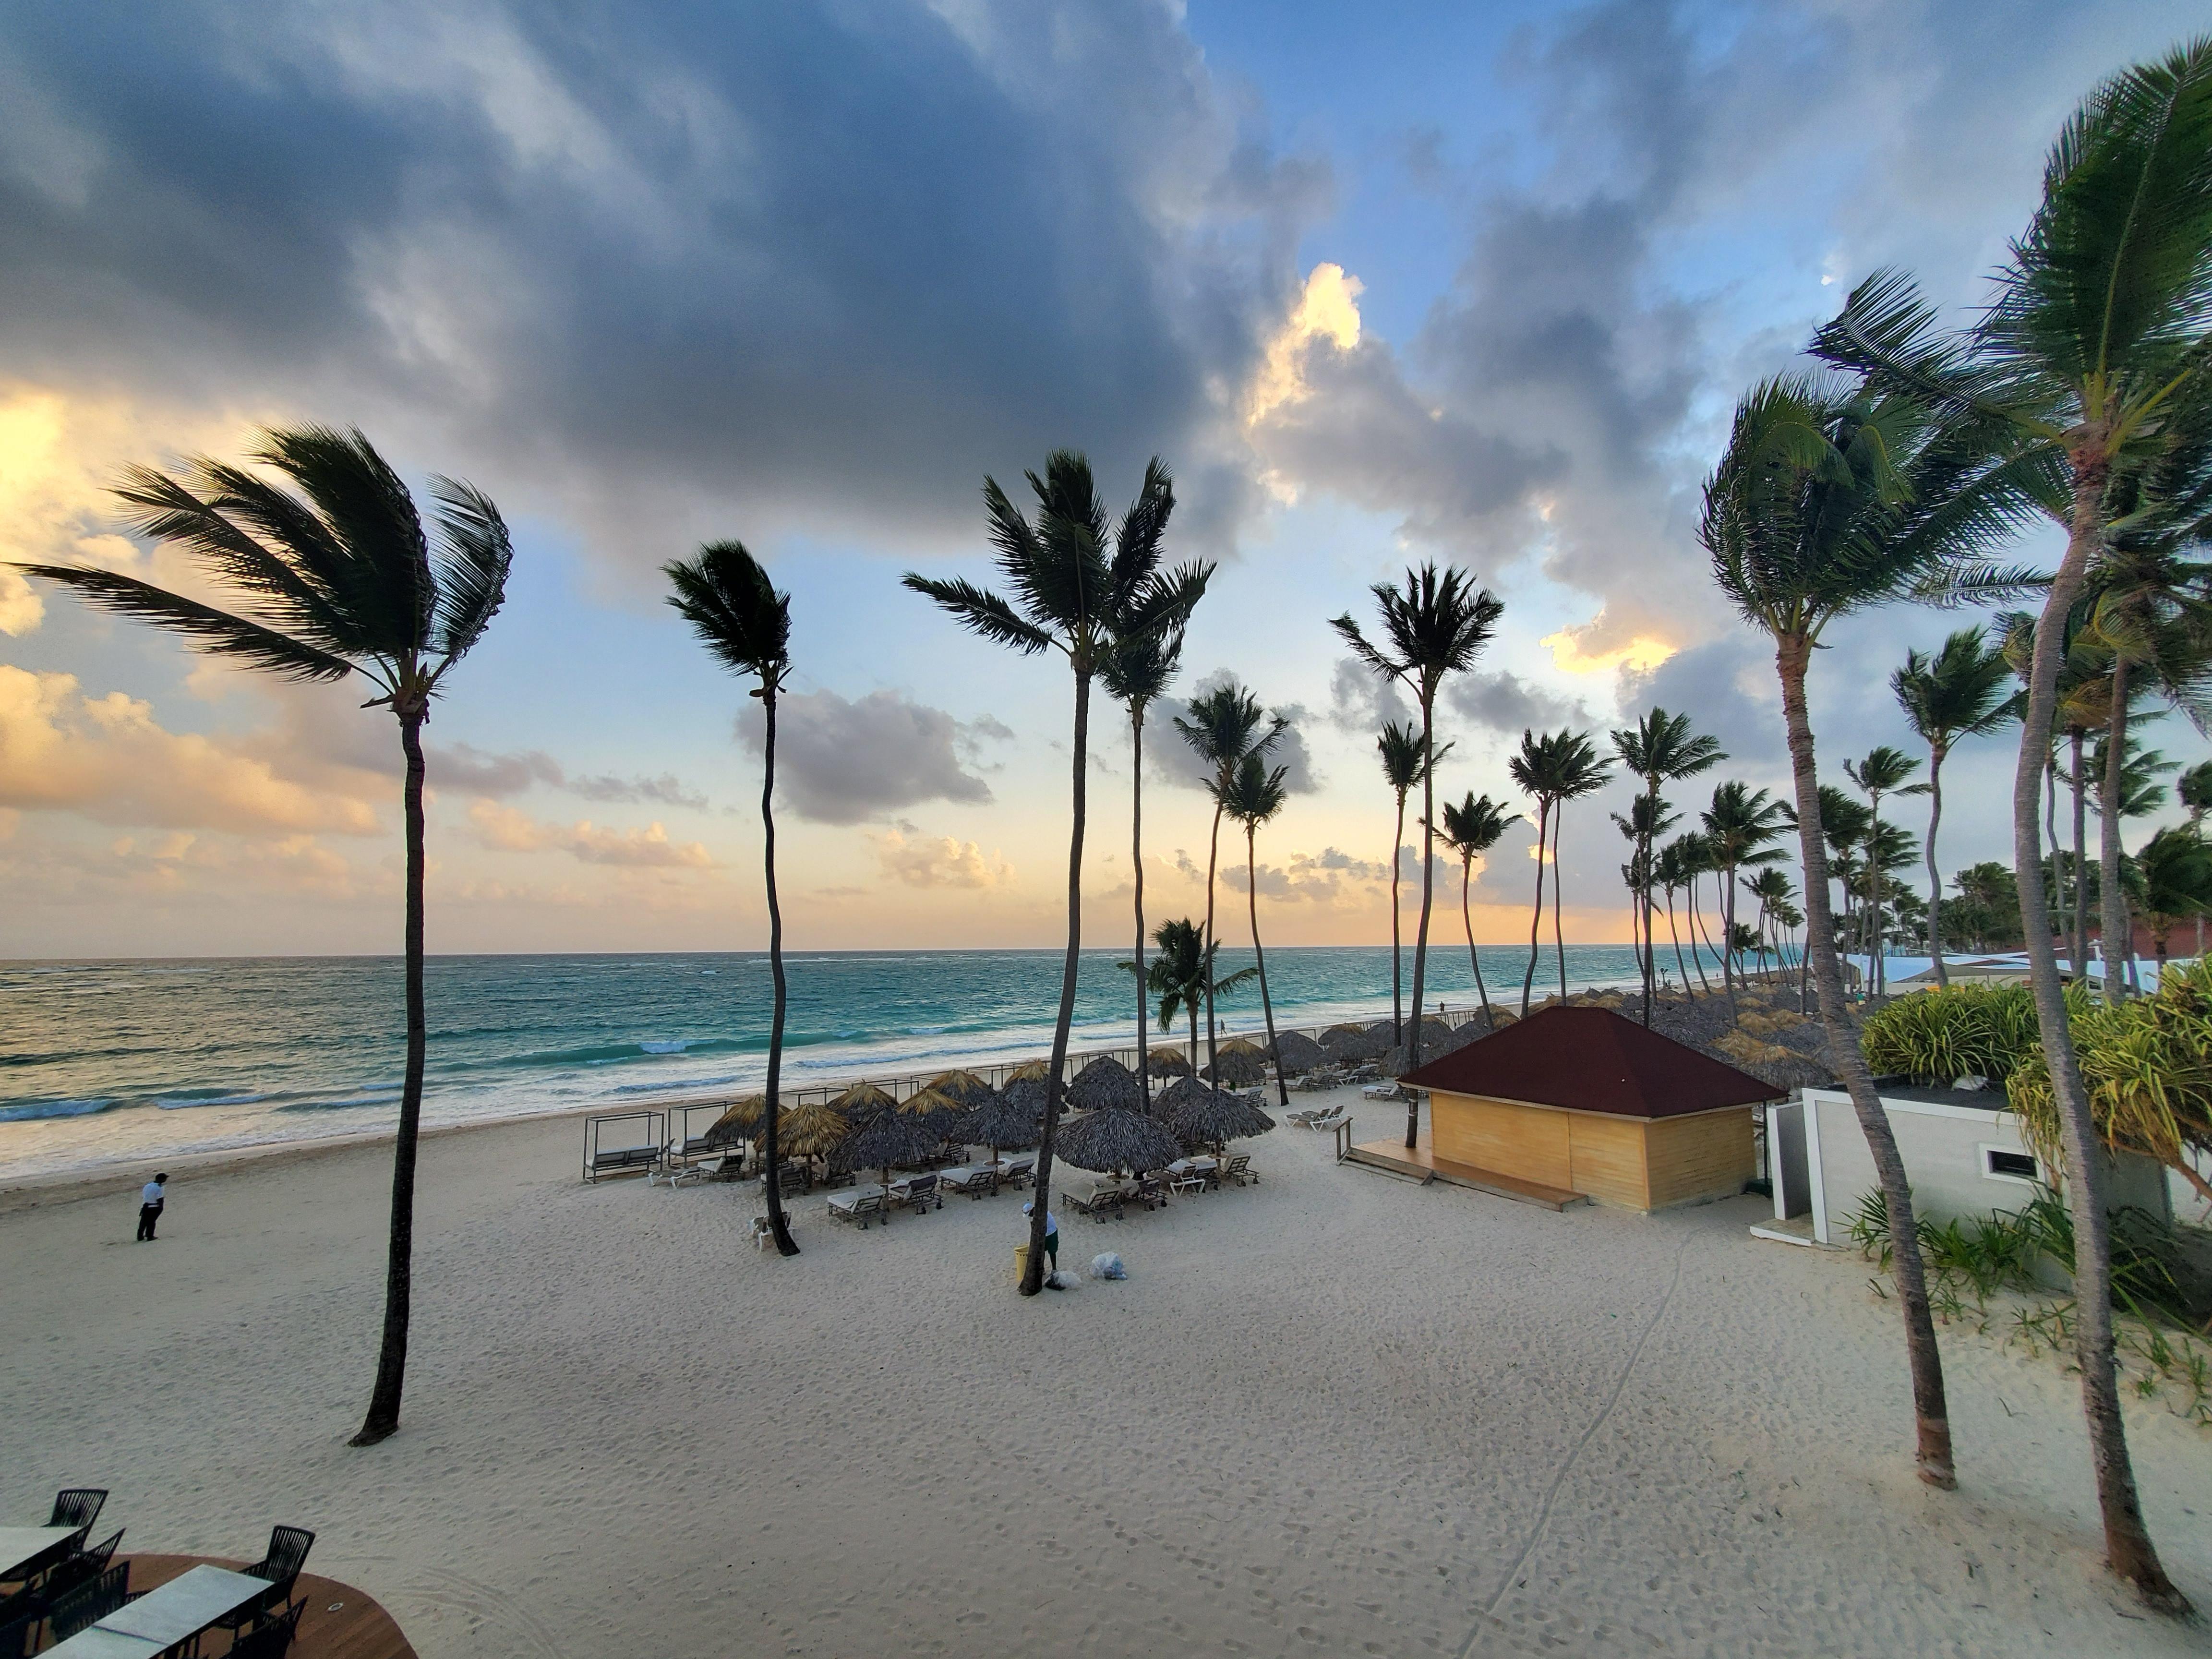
[1699,376,2024,1489]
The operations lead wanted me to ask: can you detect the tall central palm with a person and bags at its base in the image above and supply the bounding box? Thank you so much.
[905,449,1210,1296]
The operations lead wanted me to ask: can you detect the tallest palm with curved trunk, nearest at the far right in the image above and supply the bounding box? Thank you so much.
[1816,36,2212,1612]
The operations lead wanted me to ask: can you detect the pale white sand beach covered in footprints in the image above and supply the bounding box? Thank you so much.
[0,1083,2212,1659]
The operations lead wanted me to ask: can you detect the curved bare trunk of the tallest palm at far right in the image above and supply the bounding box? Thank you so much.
[2013,464,2188,1612]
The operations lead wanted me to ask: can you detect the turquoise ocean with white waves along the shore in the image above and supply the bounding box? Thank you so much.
[0,942,1663,1179]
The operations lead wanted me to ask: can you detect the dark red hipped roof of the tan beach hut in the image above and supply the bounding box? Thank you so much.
[1398,1007,1790,1117]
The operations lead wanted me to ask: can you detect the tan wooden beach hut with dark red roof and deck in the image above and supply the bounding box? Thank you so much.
[1354,1007,1787,1210]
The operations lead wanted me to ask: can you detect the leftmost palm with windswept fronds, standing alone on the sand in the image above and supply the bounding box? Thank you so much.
[18,427,513,1447]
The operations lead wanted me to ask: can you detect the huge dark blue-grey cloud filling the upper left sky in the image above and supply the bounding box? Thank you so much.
[0,0,1329,557]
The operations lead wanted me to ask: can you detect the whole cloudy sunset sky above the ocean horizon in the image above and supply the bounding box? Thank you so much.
[0,0,2205,958]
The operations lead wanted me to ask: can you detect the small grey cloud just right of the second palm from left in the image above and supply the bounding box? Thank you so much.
[736,690,996,823]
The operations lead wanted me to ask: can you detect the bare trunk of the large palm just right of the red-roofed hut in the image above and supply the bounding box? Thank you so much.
[1774,637,1964,1491]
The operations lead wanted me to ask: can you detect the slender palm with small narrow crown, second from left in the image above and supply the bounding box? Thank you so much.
[661,542,798,1256]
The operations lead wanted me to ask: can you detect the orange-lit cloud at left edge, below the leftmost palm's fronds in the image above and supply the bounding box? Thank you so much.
[0,663,378,836]
